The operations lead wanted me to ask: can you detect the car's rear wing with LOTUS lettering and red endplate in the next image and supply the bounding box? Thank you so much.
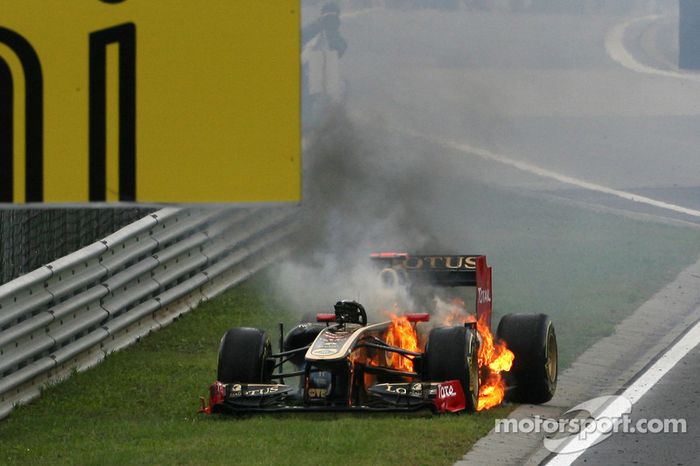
[370,252,493,327]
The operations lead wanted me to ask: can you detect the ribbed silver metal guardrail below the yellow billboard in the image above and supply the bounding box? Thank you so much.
[0,208,294,418]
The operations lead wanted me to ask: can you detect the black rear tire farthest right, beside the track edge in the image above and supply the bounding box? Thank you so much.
[496,314,558,404]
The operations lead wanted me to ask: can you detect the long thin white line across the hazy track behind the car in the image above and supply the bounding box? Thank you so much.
[424,131,700,218]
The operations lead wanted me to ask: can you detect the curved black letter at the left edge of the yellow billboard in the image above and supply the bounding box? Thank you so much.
[0,27,44,202]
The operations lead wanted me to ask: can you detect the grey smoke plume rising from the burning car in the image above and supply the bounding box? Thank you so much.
[274,105,463,311]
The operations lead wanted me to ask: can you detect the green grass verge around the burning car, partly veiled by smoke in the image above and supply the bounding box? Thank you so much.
[0,183,700,465]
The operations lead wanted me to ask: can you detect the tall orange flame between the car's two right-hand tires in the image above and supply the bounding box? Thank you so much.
[443,298,515,411]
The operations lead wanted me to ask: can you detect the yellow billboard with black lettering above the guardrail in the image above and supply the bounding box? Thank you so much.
[0,0,301,203]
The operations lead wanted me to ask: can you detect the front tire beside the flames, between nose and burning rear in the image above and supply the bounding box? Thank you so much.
[423,326,479,412]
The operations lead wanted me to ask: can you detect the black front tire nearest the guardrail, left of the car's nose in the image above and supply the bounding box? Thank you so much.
[217,328,272,383]
